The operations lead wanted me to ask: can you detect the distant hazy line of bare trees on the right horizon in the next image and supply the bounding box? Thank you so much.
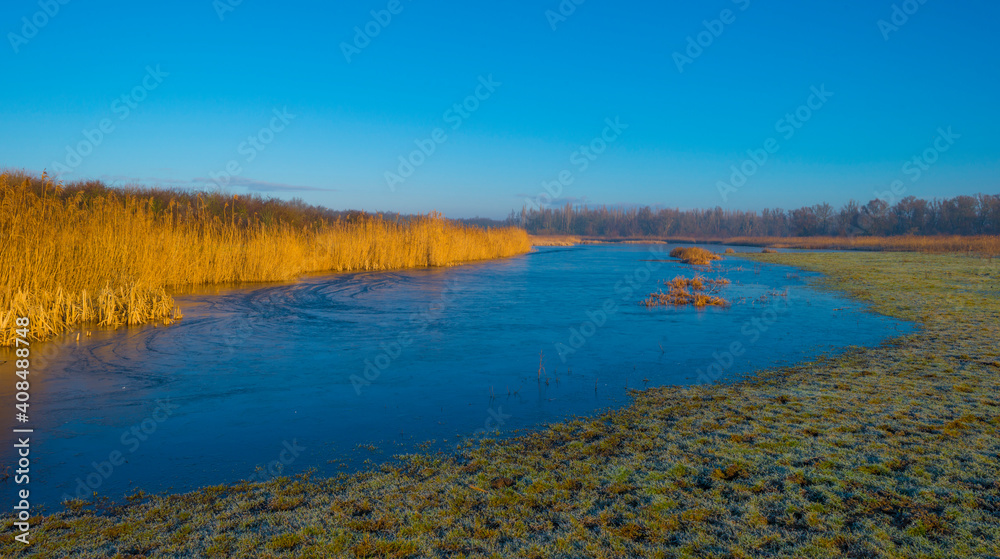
[507,194,1000,238]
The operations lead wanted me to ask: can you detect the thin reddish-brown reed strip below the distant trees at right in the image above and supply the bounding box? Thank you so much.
[720,235,1000,256]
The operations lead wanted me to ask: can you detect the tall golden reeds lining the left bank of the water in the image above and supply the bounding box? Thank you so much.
[0,173,531,345]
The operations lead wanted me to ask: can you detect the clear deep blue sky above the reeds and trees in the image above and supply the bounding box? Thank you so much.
[0,0,1000,217]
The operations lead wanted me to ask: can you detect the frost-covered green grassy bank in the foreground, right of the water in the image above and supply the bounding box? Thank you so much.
[0,253,1000,559]
